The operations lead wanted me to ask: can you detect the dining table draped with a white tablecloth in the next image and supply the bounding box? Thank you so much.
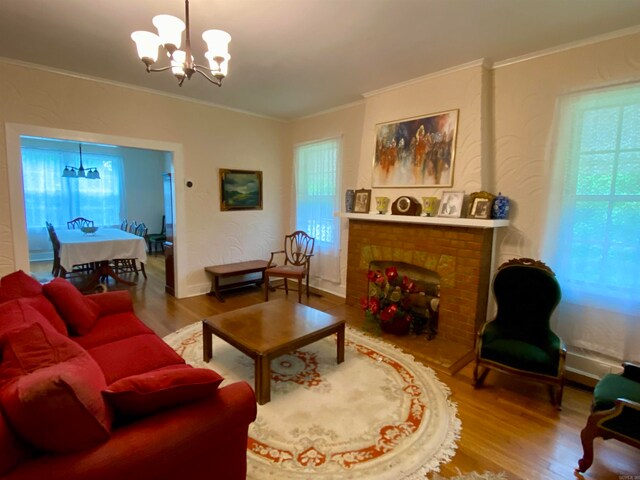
[57,227,147,290]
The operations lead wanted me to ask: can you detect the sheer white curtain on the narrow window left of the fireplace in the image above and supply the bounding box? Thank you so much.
[294,138,340,284]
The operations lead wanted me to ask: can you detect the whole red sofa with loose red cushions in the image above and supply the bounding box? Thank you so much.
[0,271,256,480]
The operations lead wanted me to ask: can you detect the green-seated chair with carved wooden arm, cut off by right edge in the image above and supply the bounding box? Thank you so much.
[577,362,640,473]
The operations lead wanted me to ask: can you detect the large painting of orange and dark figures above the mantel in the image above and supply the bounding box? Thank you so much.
[372,110,459,188]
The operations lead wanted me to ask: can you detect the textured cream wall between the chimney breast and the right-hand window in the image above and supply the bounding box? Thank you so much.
[494,34,640,261]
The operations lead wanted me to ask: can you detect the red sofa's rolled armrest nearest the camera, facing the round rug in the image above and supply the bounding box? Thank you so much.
[4,382,256,480]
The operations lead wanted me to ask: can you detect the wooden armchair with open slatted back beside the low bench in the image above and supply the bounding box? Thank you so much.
[264,230,315,303]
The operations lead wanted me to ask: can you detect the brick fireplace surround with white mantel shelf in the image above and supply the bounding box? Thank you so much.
[346,215,503,347]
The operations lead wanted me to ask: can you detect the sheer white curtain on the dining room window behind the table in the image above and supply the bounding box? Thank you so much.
[22,146,125,260]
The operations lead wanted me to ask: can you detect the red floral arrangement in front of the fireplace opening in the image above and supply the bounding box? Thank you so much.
[360,267,425,333]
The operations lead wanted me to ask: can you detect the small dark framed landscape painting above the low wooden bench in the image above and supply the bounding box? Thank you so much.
[220,168,262,211]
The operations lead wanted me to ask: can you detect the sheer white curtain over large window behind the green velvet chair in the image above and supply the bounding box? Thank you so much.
[544,85,640,360]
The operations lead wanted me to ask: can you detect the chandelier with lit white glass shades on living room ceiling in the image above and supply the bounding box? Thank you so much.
[131,0,231,87]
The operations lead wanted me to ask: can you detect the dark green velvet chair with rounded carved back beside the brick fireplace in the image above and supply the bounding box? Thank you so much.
[473,258,567,409]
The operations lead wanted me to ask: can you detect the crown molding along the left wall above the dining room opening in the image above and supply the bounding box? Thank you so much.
[0,57,285,123]
